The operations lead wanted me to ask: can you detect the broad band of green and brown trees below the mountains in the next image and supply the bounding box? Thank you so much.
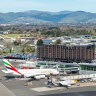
[0,25,96,37]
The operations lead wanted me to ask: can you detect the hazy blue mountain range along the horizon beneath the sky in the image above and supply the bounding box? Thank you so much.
[0,10,96,24]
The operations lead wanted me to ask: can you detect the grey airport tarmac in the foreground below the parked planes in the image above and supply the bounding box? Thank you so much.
[0,62,96,96]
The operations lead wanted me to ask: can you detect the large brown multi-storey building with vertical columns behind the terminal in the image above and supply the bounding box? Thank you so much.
[37,44,95,63]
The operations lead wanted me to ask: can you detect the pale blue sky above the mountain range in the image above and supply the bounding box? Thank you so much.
[0,0,96,13]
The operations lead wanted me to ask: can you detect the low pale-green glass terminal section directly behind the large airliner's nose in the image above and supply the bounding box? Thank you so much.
[37,61,79,72]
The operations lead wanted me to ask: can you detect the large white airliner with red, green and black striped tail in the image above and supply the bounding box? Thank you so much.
[2,59,59,79]
